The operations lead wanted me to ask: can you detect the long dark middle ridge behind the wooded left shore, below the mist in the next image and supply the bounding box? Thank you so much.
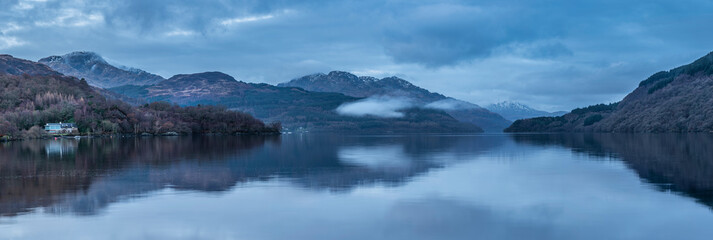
[109,72,482,133]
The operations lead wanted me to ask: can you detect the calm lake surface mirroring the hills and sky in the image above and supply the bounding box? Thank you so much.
[0,134,713,240]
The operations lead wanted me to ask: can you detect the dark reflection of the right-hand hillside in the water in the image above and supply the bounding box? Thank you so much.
[513,134,713,208]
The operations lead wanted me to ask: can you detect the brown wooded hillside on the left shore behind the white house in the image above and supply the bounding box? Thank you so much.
[0,55,281,139]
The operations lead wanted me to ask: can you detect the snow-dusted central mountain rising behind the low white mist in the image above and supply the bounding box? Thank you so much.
[277,71,511,132]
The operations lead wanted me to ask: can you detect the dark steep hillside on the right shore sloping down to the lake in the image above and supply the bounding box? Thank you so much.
[506,52,713,132]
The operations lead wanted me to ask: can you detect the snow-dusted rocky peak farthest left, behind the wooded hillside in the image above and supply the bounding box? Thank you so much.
[39,52,164,88]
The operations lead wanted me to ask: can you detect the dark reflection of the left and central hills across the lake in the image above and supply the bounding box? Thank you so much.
[0,135,507,218]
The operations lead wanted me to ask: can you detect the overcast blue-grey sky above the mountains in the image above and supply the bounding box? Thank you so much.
[0,0,713,110]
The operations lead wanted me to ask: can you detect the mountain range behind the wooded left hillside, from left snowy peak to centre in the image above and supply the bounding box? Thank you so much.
[40,52,510,133]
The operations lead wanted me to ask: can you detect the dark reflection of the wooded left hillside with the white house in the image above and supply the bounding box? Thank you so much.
[0,137,266,215]
